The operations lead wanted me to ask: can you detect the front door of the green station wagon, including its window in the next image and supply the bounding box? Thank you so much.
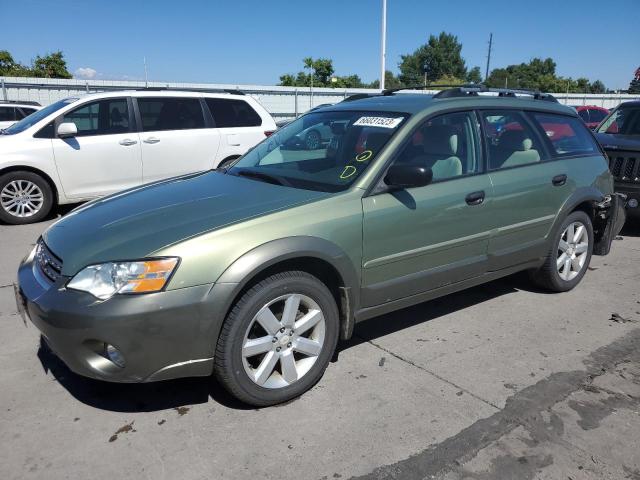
[362,112,492,307]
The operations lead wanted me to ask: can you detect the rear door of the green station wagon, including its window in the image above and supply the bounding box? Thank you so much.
[480,110,571,271]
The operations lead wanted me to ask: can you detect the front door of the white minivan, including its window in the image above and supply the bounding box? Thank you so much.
[52,97,142,200]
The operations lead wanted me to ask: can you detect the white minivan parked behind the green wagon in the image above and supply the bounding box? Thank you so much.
[0,89,276,224]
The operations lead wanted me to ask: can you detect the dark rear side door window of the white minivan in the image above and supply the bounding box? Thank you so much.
[137,97,205,132]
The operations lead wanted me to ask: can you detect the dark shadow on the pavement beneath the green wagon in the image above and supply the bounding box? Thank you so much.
[37,274,532,412]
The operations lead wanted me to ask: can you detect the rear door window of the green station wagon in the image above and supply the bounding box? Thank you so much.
[481,110,543,170]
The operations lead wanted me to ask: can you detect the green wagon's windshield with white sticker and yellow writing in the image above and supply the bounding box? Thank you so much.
[228,111,407,192]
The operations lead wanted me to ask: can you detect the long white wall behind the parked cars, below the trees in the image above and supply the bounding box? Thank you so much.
[0,77,640,119]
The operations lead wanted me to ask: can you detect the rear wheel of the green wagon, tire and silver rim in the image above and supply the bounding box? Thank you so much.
[531,211,593,292]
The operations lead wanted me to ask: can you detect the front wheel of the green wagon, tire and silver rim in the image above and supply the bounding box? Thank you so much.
[214,271,339,407]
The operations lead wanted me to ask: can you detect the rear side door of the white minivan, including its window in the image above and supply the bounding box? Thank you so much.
[136,96,220,183]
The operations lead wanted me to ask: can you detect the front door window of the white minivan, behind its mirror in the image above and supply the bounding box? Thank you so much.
[62,98,129,137]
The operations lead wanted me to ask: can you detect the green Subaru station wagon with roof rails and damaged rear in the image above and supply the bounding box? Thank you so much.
[16,86,625,406]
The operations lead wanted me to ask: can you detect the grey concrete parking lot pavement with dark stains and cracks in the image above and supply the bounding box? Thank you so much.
[0,218,640,480]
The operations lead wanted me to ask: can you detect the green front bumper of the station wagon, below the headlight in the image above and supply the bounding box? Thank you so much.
[16,257,223,382]
